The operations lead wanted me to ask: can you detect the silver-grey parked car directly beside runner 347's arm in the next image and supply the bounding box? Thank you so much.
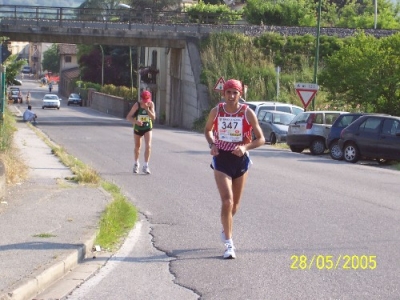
[258,110,296,145]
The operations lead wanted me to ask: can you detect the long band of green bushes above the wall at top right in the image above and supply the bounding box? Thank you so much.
[243,0,400,29]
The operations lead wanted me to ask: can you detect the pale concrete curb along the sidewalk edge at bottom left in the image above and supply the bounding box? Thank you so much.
[0,233,97,300]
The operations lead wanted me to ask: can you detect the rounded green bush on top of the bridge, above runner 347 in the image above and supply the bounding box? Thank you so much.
[186,0,242,24]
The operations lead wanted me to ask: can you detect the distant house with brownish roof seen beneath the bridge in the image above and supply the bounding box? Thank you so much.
[58,44,80,96]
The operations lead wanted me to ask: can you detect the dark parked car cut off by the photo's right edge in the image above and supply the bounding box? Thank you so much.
[338,115,400,163]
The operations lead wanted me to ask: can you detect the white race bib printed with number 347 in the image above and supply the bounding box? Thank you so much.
[218,117,243,142]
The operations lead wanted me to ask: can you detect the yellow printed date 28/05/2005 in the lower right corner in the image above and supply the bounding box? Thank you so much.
[290,254,377,270]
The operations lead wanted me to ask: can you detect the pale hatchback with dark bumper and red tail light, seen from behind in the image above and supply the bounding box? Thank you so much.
[286,111,347,155]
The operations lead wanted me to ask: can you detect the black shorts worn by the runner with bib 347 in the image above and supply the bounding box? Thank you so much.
[210,150,251,179]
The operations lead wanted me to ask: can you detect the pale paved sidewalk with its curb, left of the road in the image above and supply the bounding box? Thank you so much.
[0,105,111,300]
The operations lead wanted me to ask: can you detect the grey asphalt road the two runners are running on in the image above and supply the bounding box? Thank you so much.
[16,78,400,300]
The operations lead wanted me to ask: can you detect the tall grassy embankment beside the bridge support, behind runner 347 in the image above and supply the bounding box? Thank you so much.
[200,33,312,106]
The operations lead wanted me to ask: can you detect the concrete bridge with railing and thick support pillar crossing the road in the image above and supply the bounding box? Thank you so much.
[0,5,393,128]
